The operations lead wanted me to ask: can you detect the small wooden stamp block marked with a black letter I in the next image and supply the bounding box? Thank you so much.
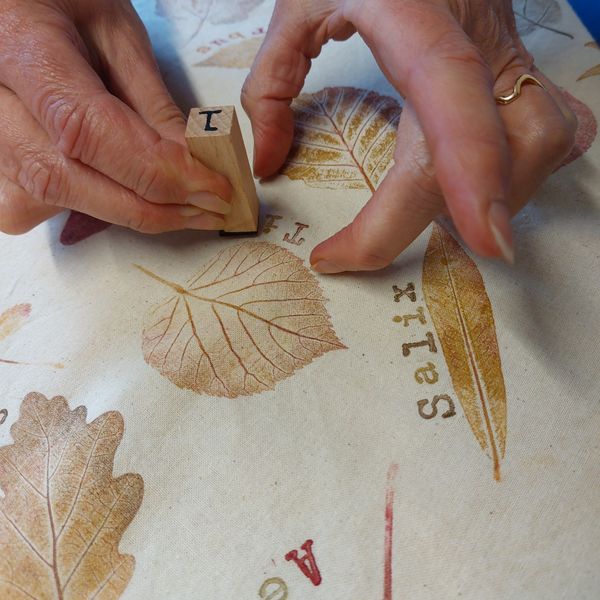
[185,106,259,233]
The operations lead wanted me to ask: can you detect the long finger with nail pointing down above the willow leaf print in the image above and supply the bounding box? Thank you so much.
[350,0,512,260]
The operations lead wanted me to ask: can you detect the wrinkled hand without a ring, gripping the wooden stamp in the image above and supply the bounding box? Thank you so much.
[0,0,231,233]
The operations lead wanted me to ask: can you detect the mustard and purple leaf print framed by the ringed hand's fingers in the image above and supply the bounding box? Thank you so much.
[282,87,402,192]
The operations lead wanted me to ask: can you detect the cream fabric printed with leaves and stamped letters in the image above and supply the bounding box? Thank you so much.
[0,0,600,600]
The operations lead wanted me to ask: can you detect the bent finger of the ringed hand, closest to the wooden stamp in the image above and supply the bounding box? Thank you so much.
[242,0,354,177]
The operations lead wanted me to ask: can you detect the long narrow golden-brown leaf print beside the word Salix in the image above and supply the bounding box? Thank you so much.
[423,224,506,481]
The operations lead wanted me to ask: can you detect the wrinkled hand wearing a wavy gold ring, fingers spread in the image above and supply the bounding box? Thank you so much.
[242,0,576,273]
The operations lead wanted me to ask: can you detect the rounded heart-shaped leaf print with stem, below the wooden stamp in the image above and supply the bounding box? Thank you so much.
[138,242,345,398]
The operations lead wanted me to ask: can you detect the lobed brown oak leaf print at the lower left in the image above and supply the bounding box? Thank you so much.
[0,393,143,600]
